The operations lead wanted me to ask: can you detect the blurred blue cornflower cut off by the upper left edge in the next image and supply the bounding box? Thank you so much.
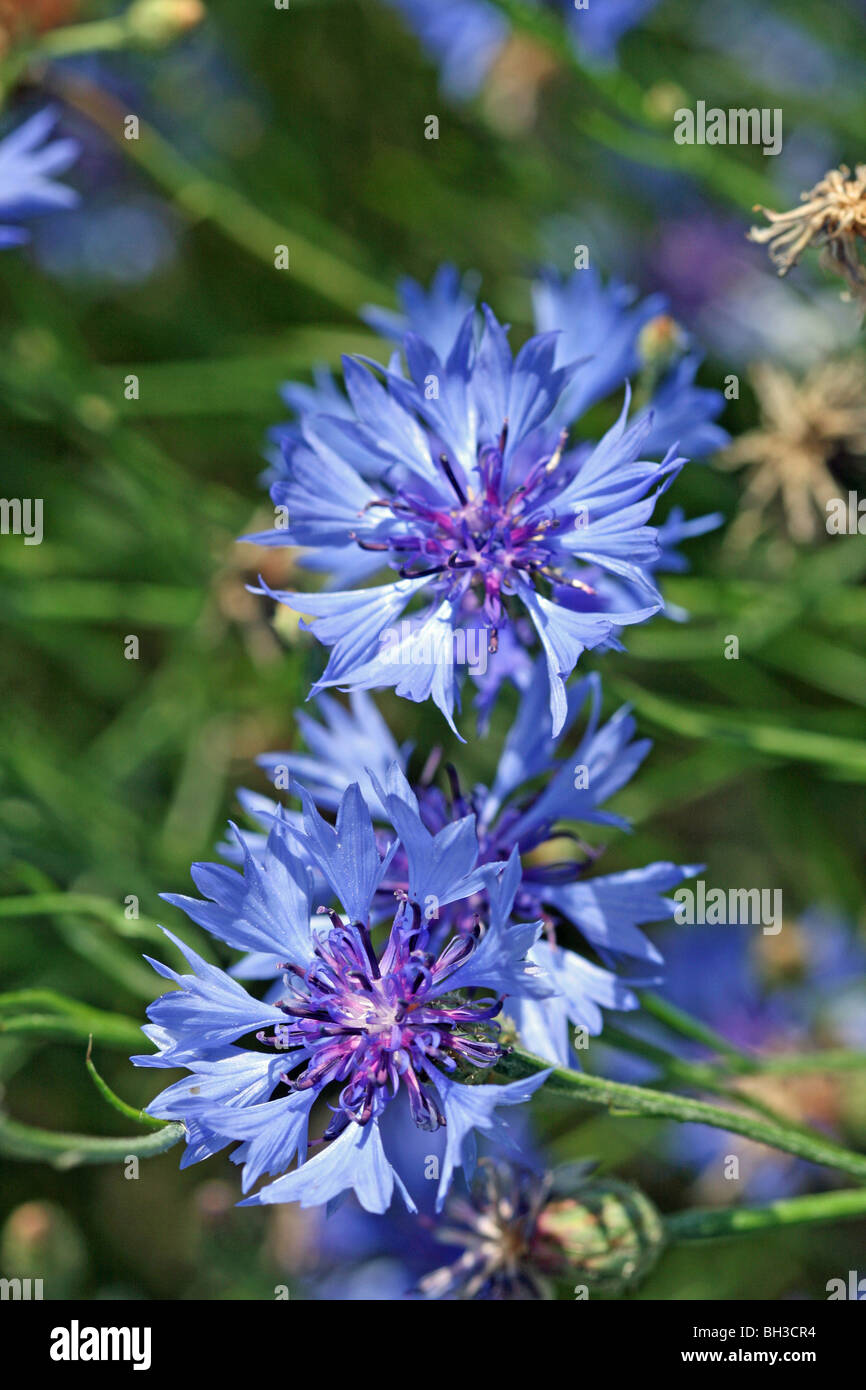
[0,107,79,247]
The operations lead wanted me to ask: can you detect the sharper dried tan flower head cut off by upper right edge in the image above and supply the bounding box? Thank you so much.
[748,164,866,311]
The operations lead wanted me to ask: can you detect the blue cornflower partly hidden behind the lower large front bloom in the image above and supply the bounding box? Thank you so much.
[228,671,695,1066]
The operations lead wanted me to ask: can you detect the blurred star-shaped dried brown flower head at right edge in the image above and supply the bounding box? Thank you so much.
[719,357,866,542]
